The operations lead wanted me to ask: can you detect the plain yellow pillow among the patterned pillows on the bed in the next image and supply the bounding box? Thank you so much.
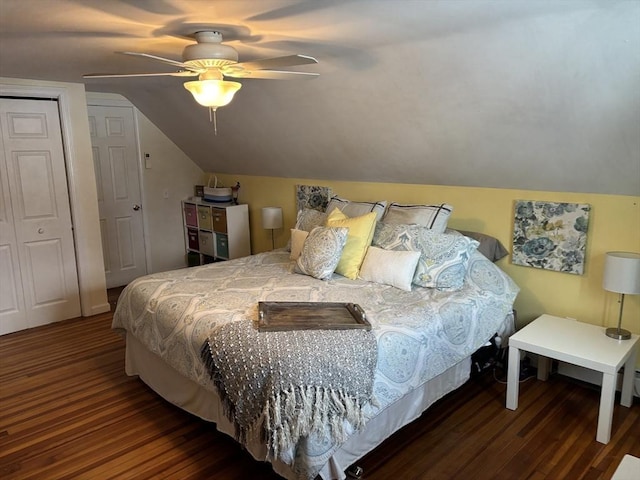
[327,208,377,280]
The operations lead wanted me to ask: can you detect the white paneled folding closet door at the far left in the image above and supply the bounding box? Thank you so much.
[0,98,80,334]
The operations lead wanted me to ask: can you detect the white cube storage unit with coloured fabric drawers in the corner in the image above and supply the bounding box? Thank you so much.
[182,200,251,266]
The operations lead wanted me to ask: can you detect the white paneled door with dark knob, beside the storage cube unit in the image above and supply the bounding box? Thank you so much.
[88,105,147,288]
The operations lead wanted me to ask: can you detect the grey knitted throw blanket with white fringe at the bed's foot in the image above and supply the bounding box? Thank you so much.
[202,321,377,463]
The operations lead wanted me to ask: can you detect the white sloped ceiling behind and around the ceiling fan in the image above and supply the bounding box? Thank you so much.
[0,0,640,195]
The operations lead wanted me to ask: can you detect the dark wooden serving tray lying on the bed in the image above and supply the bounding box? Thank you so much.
[258,302,371,332]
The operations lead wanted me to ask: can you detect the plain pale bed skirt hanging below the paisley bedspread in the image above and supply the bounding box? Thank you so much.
[125,335,471,480]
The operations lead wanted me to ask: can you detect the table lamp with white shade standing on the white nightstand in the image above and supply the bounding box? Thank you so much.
[602,252,640,340]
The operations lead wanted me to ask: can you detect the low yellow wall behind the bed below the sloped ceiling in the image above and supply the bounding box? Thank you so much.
[211,175,640,334]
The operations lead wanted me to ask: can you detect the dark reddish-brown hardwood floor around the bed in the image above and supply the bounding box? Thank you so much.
[0,306,640,480]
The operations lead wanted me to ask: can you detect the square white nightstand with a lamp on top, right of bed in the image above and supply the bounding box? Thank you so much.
[507,315,640,443]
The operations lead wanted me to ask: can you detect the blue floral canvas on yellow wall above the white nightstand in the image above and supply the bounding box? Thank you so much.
[512,200,591,275]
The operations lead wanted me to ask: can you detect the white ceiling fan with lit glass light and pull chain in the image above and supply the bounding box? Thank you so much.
[83,29,318,133]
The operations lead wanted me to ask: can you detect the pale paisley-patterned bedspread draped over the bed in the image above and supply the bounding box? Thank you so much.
[113,250,519,478]
